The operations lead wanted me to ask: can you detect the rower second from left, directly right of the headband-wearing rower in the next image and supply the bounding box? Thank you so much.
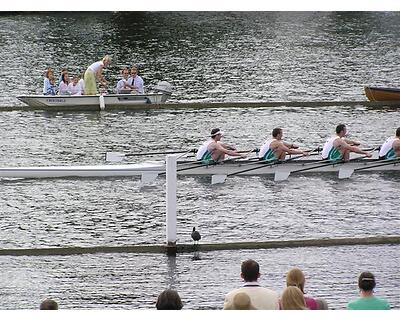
[258,128,309,162]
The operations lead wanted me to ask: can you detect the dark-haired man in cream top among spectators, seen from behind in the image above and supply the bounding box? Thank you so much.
[224,259,279,310]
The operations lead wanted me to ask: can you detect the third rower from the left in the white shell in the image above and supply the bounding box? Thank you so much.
[321,124,372,161]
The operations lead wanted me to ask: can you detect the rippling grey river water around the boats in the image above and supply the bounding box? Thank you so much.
[0,12,400,309]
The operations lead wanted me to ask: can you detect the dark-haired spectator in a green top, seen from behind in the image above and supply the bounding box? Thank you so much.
[347,271,390,310]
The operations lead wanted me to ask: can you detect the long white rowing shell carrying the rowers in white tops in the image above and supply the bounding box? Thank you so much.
[0,159,400,178]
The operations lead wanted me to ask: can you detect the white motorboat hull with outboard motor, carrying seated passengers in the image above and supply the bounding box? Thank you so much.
[17,81,172,110]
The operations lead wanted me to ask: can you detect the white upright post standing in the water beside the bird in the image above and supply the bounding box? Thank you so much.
[165,155,178,246]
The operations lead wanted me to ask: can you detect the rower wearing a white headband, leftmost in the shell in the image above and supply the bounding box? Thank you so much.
[196,128,246,163]
